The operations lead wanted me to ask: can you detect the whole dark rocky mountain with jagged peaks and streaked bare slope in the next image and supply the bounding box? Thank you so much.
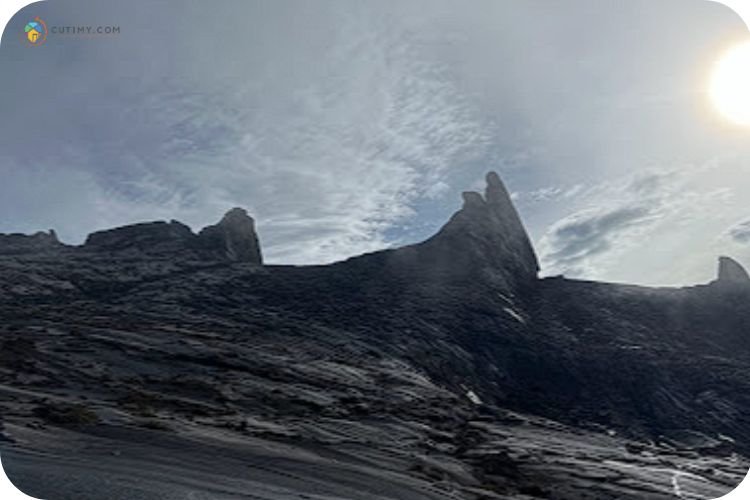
[0,173,750,500]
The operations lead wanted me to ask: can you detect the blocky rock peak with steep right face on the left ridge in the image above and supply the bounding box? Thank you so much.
[198,208,263,264]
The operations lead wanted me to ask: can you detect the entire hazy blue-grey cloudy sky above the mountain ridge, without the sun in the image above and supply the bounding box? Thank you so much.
[0,0,750,286]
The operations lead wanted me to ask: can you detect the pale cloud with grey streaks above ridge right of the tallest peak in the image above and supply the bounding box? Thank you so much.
[537,160,750,285]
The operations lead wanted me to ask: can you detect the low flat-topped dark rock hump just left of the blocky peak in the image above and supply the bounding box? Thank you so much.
[84,220,195,253]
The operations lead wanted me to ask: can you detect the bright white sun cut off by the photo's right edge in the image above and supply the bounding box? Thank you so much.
[710,41,750,126]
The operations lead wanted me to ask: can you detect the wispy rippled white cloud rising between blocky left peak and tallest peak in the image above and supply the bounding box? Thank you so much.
[206,11,488,263]
